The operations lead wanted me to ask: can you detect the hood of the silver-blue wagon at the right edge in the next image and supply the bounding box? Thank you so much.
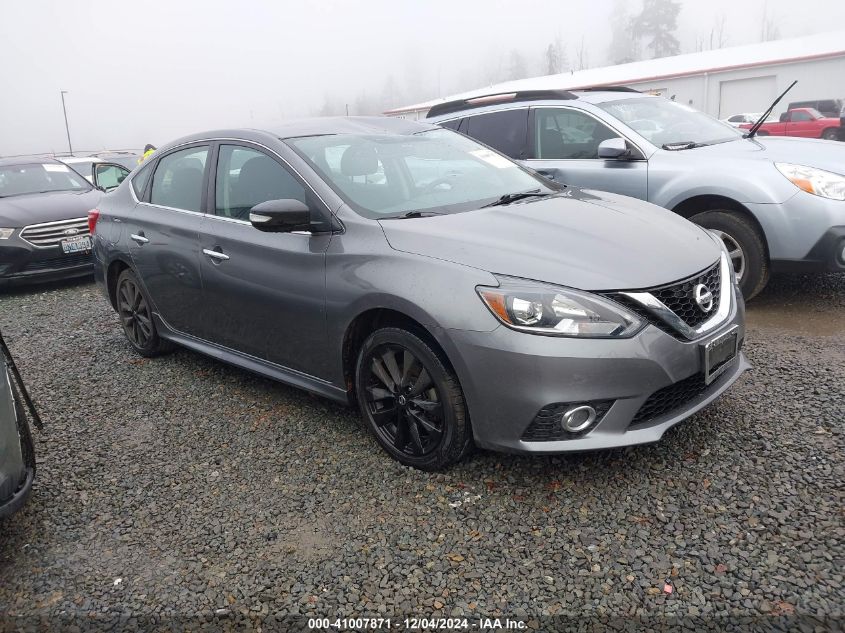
[684,136,845,174]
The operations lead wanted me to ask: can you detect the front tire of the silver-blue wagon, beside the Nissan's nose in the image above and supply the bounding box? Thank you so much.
[690,210,769,301]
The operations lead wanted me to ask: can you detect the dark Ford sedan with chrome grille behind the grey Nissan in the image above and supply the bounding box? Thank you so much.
[0,158,102,286]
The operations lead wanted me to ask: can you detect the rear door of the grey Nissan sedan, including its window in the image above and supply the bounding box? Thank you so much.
[124,143,210,336]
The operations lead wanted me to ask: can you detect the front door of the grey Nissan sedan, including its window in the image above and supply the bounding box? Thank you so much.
[200,144,331,376]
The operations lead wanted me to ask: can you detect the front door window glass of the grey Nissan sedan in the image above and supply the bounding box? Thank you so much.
[215,145,308,220]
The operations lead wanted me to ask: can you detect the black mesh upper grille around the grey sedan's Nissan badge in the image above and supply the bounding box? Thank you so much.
[605,262,722,338]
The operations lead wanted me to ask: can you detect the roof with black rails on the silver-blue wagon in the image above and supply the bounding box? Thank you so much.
[426,88,657,121]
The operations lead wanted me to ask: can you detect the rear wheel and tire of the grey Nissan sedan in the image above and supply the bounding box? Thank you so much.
[115,268,173,358]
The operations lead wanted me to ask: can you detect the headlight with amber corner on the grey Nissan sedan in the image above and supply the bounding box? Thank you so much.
[477,277,643,338]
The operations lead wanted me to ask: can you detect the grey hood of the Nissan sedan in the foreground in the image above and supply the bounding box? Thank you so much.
[380,188,720,290]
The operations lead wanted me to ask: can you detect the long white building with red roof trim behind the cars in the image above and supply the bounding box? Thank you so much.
[385,31,845,119]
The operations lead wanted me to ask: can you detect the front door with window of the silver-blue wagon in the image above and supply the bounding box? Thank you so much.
[525,107,648,200]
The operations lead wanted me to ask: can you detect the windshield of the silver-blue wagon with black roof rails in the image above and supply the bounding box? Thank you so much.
[599,97,742,147]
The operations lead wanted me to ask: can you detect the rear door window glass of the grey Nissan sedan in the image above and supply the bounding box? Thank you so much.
[150,146,208,213]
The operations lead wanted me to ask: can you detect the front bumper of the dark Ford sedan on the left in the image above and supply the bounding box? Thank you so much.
[0,233,93,286]
